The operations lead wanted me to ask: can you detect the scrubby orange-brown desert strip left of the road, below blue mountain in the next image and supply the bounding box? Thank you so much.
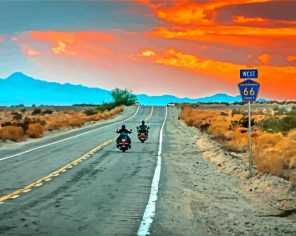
[0,106,124,142]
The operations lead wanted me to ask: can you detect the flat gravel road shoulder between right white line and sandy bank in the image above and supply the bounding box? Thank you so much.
[152,108,296,235]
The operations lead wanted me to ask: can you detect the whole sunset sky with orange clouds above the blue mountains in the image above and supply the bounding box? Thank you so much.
[0,0,296,100]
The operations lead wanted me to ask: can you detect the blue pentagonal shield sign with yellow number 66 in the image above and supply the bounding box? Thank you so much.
[238,79,260,102]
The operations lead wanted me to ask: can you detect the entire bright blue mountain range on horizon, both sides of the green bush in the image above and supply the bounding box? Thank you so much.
[0,72,262,106]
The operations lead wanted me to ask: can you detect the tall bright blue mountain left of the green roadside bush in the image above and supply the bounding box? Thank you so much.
[0,72,112,106]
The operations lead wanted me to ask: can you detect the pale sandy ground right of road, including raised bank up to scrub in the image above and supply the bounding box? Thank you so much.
[152,108,296,235]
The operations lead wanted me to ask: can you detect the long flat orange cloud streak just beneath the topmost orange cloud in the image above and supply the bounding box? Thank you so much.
[148,26,296,50]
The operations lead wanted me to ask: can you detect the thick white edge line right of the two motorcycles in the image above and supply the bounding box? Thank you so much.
[137,107,168,236]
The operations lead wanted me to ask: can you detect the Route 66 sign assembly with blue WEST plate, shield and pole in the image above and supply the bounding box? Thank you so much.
[238,69,260,177]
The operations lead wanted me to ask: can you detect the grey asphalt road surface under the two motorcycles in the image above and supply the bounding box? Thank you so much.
[0,107,165,235]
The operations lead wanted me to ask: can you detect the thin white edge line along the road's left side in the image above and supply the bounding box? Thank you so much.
[0,106,140,161]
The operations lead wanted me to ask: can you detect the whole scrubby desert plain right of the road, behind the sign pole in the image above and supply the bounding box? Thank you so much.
[180,103,296,186]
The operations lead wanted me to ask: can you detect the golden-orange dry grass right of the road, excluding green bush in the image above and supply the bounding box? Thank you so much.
[180,106,296,185]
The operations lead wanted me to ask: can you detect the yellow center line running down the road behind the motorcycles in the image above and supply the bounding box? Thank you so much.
[0,107,154,204]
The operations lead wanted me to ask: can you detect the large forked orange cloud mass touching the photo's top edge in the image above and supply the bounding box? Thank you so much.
[142,0,296,49]
